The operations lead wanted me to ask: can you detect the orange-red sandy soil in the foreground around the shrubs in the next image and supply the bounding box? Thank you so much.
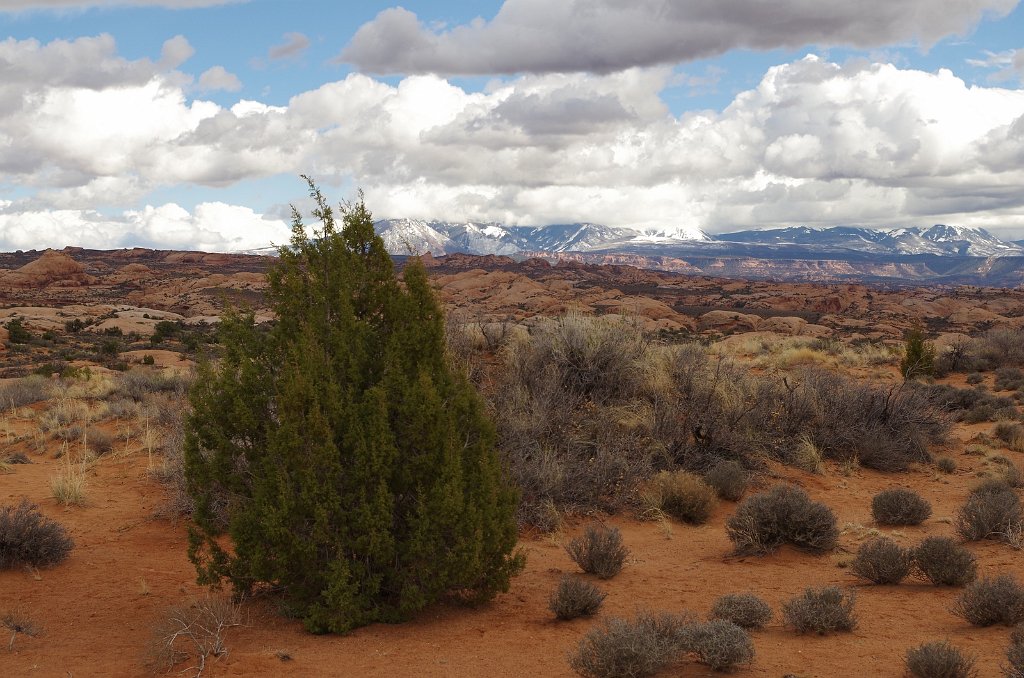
[0,405,1024,678]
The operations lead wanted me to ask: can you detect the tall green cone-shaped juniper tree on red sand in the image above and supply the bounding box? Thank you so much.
[184,177,522,633]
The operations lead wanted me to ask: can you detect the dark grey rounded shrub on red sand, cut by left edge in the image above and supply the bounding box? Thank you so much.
[0,499,75,569]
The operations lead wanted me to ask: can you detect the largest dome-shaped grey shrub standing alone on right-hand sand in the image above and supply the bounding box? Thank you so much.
[726,484,839,554]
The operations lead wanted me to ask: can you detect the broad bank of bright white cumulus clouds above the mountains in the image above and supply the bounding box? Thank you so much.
[6,31,1024,249]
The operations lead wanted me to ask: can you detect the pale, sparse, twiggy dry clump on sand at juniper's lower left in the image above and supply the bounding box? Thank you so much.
[148,597,242,676]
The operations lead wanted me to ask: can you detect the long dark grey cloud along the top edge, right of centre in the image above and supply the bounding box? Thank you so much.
[339,0,1019,75]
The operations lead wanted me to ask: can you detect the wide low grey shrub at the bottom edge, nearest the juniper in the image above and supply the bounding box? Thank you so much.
[569,611,692,678]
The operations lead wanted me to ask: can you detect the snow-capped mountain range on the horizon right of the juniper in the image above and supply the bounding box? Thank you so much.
[375,219,1024,257]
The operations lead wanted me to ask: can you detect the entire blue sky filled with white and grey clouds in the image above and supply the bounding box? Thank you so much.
[0,0,1024,251]
